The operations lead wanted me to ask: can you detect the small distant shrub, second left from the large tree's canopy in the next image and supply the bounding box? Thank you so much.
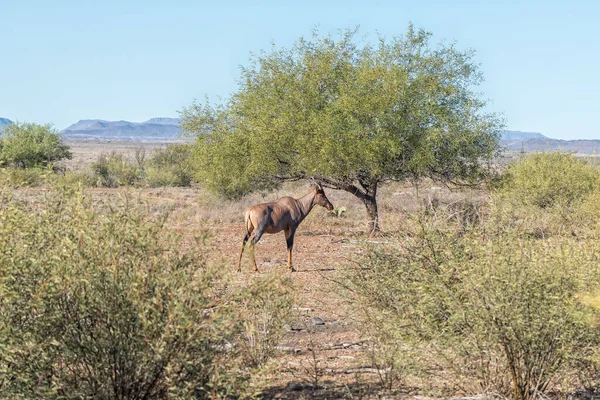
[90,151,143,188]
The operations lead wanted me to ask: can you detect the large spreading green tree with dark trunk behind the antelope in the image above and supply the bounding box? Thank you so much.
[182,25,500,230]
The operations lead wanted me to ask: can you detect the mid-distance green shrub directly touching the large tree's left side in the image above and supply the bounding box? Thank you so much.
[145,144,192,187]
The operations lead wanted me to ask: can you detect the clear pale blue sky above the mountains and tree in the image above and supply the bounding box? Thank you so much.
[0,0,600,139]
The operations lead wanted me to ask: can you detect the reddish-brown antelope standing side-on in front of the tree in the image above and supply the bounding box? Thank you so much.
[238,185,333,272]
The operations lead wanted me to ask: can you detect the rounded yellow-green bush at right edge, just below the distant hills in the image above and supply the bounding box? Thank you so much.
[501,153,600,208]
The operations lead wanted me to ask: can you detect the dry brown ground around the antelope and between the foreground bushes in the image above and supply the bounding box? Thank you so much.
[49,141,490,399]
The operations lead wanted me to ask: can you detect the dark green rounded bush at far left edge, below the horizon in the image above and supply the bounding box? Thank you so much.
[0,122,71,168]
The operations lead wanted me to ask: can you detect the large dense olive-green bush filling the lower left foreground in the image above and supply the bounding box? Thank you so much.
[0,191,290,399]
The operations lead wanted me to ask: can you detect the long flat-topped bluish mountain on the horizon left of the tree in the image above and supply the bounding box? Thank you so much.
[62,118,181,142]
